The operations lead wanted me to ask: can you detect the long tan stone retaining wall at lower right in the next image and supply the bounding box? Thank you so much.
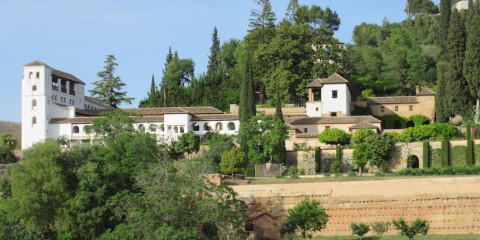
[232,176,480,239]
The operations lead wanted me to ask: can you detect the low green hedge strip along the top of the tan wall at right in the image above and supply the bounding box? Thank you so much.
[396,166,480,176]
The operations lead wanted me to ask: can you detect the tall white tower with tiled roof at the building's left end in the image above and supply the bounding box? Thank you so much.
[22,61,85,149]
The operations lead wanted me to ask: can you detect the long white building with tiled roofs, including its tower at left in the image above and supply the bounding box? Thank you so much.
[22,61,240,149]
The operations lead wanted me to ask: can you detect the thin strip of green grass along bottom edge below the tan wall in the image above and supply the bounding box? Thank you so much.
[286,235,480,240]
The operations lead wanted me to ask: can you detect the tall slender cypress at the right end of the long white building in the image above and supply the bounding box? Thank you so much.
[238,56,256,152]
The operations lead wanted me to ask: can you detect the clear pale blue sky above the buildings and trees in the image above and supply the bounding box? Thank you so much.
[0,0,439,122]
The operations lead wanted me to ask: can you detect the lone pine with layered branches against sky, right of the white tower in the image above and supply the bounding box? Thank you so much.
[89,55,134,107]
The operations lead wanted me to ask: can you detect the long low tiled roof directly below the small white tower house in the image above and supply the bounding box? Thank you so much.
[285,116,382,125]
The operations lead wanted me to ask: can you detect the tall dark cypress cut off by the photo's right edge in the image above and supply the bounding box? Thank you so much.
[463,13,480,124]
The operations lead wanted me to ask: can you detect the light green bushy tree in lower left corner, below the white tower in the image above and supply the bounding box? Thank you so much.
[5,139,71,233]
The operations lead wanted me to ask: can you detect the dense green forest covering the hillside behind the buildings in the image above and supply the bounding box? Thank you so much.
[132,0,480,124]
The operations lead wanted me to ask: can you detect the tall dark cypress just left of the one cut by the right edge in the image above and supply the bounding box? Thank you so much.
[446,10,471,116]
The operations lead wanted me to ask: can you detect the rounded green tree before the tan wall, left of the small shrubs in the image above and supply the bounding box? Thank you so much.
[280,198,328,238]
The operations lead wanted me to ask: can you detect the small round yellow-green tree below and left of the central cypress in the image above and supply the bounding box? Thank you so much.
[220,148,248,178]
